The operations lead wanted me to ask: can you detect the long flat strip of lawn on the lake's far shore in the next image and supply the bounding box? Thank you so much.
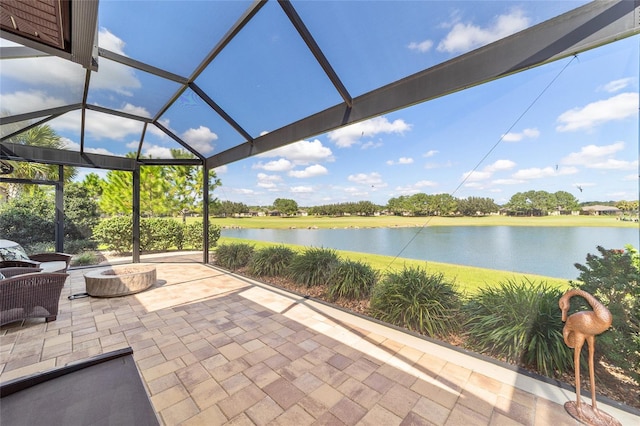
[206,216,638,229]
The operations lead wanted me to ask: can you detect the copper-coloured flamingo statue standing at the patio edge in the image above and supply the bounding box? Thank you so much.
[558,289,620,425]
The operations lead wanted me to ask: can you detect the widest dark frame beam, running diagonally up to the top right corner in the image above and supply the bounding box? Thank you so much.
[207,0,640,168]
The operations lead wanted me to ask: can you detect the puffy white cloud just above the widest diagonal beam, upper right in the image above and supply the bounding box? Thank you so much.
[437,10,530,53]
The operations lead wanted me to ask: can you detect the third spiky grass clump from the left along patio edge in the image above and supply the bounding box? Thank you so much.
[289,247,340,287]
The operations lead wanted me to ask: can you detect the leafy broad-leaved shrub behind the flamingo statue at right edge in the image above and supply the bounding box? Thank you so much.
[572,245,640,381]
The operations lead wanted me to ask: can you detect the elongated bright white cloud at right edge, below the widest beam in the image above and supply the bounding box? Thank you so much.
[556,92,638,132]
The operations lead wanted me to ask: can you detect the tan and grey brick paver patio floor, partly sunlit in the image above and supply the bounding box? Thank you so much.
[0,256,640,426]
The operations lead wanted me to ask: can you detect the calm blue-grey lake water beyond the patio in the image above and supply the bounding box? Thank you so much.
[222,226,639,279]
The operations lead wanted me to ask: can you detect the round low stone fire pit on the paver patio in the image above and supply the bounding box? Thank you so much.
[84,265,156,297]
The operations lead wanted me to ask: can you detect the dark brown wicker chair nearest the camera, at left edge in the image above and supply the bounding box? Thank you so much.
[0,272,69,325]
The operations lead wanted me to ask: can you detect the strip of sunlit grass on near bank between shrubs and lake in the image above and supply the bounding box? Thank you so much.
[218,237,569,294]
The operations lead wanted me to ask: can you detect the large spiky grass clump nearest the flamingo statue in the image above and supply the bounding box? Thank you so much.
[465,280,573,376]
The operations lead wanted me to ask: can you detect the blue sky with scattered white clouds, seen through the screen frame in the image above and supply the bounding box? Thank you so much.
[0,0,640,206]
